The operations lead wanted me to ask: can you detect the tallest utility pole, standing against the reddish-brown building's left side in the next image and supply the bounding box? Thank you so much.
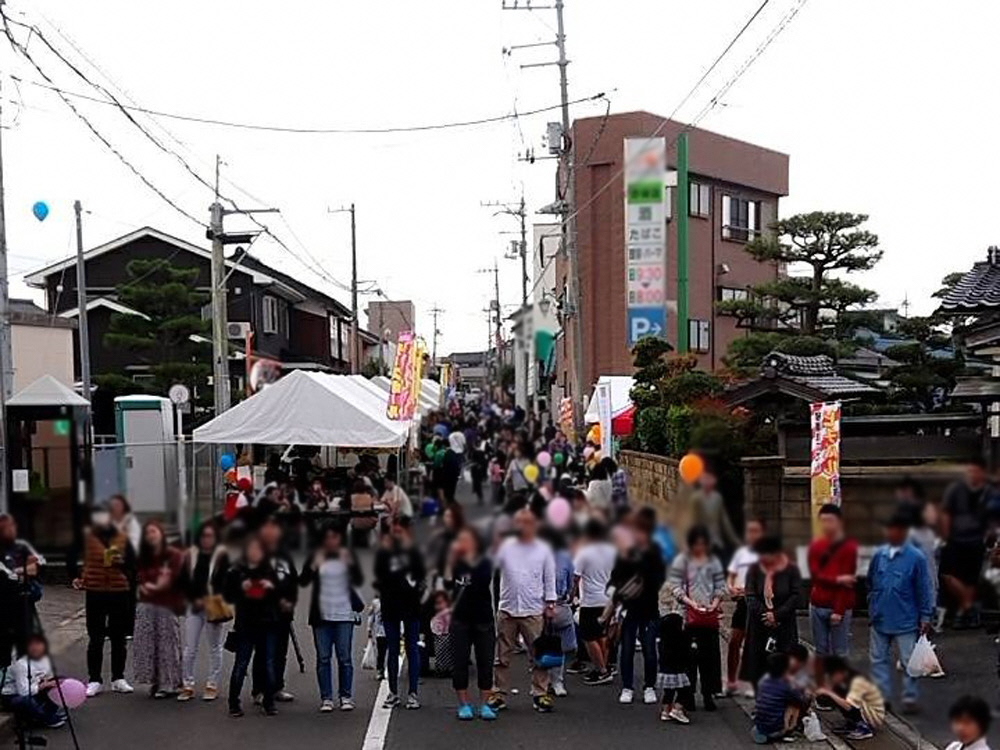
[503,0,587,419]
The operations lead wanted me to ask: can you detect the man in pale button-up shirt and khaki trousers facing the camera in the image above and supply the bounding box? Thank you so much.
[489,508,556,713]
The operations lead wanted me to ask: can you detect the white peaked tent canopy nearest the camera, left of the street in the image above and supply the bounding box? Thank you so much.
[194,370,409,448]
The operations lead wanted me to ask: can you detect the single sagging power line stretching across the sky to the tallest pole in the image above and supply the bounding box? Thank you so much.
[11,68,603,135]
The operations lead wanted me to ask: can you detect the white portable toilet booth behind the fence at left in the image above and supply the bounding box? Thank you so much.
[115,396,179,518]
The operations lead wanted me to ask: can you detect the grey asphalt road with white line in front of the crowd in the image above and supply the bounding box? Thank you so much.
[31,484,764,750]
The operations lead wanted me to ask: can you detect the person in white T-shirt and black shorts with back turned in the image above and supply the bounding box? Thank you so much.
[573,519,616,685]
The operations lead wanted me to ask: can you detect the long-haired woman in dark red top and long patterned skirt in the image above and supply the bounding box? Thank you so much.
[132,521,184,698]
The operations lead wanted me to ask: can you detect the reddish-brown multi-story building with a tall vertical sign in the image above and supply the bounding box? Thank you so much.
[553,112,788,403]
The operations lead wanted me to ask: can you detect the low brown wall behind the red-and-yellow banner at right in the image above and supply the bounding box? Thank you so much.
[743,456,962,547]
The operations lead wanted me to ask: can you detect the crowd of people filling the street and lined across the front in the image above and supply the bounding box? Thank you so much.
[0,405,1000,750]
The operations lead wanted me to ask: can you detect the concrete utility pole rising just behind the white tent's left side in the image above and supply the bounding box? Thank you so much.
[207,155,278,416]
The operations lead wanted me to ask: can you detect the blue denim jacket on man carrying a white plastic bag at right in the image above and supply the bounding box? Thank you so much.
[868,544,934,635]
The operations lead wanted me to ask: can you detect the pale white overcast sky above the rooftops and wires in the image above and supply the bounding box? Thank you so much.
[0,0,1000,352]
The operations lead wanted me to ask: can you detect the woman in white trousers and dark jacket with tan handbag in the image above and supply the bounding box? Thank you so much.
[177,522,231,701]
